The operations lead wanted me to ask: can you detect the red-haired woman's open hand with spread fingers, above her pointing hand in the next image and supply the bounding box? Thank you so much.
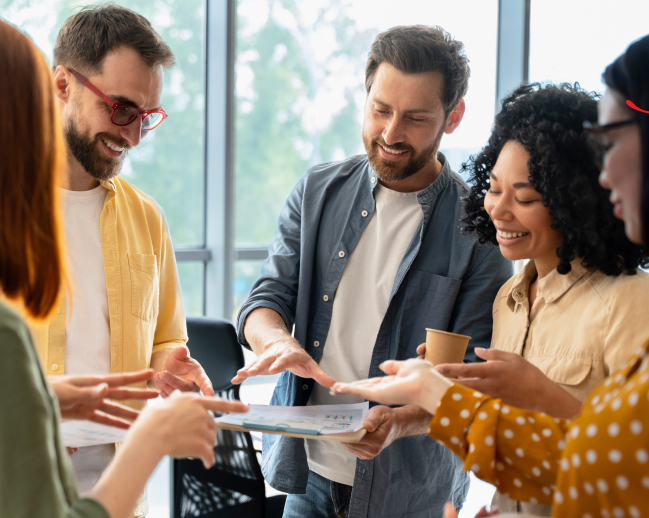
[47,369,158,429]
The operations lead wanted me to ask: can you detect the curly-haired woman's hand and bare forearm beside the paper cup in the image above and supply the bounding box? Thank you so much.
[436,347,581,417]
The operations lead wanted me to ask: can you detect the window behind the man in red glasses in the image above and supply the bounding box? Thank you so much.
[0,0,206,314]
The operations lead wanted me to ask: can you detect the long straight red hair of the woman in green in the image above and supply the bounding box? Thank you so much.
[0,21,65,318]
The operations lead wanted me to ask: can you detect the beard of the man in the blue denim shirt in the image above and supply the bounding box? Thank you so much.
[363,126,444,183]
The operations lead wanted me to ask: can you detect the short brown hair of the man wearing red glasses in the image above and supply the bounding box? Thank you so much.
[54,4,174,74]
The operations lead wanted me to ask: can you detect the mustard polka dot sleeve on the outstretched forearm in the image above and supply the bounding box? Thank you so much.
[430,384,568,504]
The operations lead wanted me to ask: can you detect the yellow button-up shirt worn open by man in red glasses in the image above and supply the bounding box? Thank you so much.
[32,177,187,408]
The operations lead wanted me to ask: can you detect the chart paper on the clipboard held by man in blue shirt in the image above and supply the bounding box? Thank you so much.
[215,401,369,435]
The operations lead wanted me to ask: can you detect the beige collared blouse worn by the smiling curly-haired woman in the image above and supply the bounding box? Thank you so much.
[491,259,649,516]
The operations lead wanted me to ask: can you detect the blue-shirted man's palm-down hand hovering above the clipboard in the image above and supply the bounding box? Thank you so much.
[232,338,336,388]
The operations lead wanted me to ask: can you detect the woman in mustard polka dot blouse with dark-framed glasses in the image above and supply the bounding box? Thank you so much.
[332,36,649,518]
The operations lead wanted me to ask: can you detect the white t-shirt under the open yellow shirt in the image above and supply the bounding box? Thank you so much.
[59,185,115,494]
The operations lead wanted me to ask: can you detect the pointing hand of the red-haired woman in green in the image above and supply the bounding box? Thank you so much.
[134,390,248,469]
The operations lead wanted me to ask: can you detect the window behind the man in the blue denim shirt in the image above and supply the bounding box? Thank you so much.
[233,0,498,317]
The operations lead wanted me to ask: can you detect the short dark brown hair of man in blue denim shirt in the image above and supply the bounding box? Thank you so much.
[365,25,471,116]
